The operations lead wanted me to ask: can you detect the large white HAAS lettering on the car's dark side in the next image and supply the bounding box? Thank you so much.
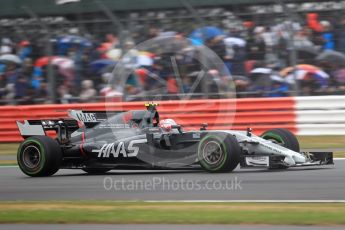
[92,139,147,158]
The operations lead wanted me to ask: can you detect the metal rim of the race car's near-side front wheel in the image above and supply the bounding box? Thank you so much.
[203,141,224,165]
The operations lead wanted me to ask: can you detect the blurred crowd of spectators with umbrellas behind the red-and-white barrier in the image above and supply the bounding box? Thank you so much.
[0,13,345,104]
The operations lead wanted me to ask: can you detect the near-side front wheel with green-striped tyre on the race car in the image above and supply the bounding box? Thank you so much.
[198,134,241,173]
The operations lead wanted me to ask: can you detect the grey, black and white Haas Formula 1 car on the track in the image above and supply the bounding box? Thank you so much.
[17,103,333,177]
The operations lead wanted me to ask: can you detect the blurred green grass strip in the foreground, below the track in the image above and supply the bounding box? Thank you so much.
[0,201,345,225]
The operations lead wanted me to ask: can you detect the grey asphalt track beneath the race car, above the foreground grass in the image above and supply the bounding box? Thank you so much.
[0,160,345,200]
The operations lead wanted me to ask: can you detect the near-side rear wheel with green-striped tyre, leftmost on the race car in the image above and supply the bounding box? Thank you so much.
[17,136,62,177]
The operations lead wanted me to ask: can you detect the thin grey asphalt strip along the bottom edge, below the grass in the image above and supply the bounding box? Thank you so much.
[0,224,344,230]
